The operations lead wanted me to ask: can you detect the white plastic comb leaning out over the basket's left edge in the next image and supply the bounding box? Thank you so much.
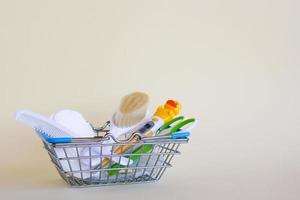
[16,110,72,138]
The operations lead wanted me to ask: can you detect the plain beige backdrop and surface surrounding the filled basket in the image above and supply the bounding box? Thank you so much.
[0,0,300,200]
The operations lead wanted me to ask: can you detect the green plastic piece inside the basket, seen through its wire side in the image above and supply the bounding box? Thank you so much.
[107,144,153,176]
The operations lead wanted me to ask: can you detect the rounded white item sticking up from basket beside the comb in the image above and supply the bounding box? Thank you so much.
[50,110,95,137]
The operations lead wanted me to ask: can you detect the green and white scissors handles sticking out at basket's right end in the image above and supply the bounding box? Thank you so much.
[156,116,197,136]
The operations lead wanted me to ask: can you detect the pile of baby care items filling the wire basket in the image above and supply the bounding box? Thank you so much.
[16,92,196,179]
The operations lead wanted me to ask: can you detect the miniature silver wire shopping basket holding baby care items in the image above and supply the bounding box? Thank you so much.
[42,122,188,187]
